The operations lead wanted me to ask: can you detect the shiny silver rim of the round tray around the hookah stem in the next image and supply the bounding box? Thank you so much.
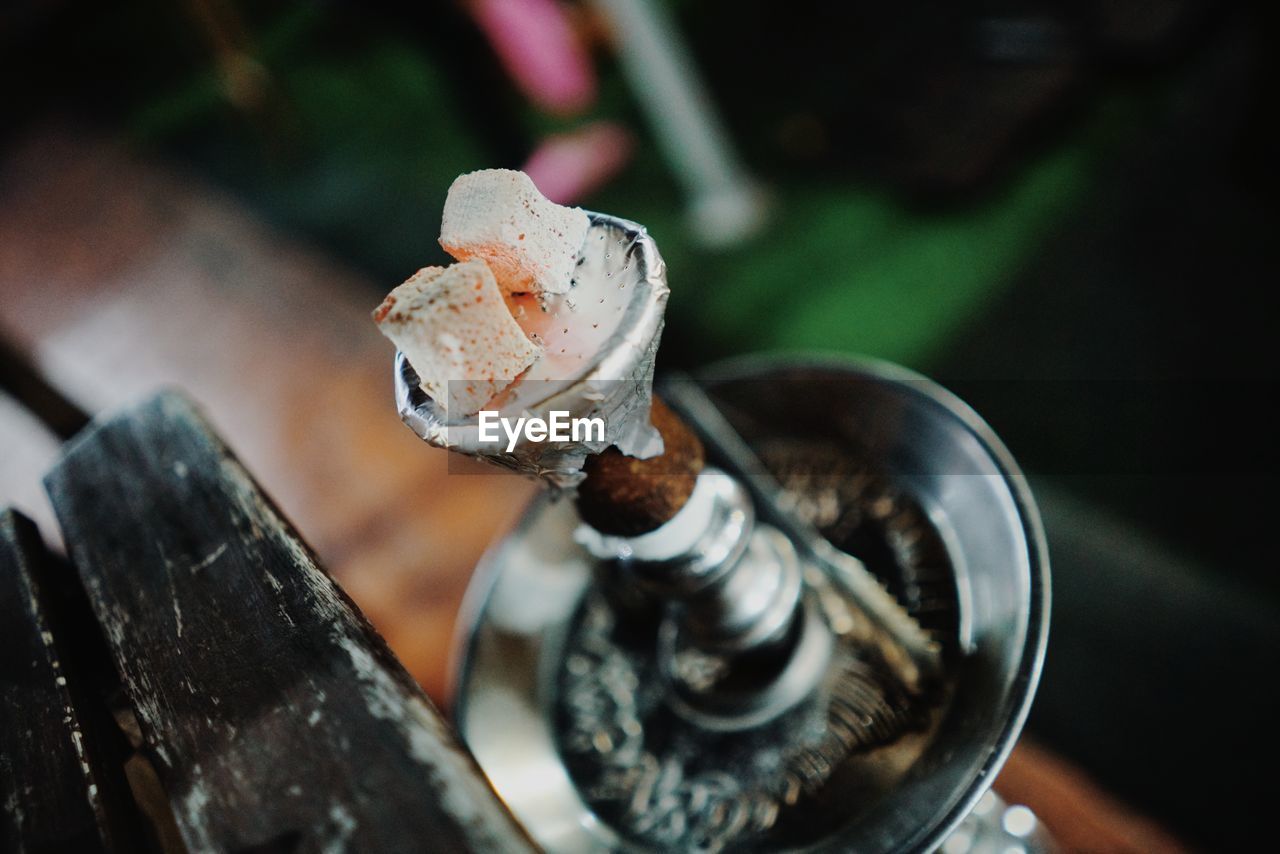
[456,360,1048,851]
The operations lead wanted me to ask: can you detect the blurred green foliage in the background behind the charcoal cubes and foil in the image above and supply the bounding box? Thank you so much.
[94,5,1131,366]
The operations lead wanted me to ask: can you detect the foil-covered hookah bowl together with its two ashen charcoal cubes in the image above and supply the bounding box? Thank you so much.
[374,169,668,488]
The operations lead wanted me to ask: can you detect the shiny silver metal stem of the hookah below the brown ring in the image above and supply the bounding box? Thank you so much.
[581,469,808,731]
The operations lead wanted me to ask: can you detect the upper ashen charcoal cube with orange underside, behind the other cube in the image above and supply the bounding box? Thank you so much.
[440,169,590,298]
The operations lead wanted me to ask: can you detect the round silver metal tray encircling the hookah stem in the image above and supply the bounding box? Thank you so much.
[454,359,1050,853]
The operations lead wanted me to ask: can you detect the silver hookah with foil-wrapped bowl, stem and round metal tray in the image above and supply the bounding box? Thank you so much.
[394,198,1048,851]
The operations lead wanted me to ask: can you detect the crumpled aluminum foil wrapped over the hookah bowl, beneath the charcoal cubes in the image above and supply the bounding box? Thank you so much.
[396,213,669,489]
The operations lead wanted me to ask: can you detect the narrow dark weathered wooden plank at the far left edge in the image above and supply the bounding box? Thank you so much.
[0,511,142,853]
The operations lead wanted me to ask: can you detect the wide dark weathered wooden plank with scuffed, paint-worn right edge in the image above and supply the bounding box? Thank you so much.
[46,394,529,851]
